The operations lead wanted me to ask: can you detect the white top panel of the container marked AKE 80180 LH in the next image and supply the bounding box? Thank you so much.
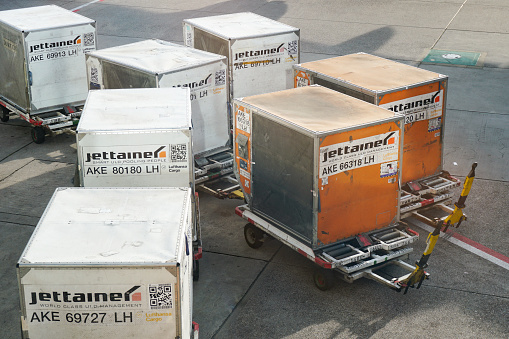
[77,88,191,132]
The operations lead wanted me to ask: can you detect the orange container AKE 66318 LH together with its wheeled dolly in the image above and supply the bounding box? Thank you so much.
[233,85,418,290]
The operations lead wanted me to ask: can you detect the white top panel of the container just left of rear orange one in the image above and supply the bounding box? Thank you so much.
[184,12,299,40]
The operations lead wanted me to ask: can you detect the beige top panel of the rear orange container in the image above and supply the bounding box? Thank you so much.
[301,53,444,92]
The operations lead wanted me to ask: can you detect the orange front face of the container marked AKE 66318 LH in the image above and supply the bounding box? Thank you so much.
[318,122,402,245]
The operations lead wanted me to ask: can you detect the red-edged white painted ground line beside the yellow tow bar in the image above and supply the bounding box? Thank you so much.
[407,218,509,270]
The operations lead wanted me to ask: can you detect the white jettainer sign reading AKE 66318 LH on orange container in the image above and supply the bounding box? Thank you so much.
[320,131,399,178]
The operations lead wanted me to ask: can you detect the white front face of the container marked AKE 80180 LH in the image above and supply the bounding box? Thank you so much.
[77,131,194,187]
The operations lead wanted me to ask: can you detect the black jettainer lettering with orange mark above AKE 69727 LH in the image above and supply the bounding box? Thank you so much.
[28,285,141,305]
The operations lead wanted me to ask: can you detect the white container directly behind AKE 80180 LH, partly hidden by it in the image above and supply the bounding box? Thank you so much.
[87,40,229,154]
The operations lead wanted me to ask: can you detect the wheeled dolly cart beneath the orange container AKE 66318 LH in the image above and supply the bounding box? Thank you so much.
[235,204,420,291]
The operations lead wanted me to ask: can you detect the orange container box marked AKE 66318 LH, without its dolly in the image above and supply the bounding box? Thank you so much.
[233,86,403,249]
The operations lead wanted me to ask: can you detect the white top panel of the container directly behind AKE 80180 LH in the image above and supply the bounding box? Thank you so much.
[89,39,226,74]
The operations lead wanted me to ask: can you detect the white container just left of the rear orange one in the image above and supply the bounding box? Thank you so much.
[184,13,300,102]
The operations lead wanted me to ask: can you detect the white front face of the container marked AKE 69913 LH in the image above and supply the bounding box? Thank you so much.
[25,25,96,113]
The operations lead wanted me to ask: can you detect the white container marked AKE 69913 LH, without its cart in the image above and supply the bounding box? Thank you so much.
[0,5,96,114]
